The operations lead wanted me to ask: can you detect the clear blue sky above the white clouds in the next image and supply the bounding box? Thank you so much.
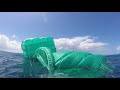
[0,12,120,54]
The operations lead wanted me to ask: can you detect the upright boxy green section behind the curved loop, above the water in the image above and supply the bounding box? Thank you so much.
[21,37,56,58]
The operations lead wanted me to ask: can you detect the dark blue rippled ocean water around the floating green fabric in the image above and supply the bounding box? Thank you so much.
[0,51,120,78]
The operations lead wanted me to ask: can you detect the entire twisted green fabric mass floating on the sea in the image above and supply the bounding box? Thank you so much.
[21,37,107,78]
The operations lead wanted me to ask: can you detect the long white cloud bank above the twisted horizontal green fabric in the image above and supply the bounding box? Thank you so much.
[55,36,108,52]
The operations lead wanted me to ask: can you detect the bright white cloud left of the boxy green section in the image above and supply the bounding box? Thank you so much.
[0,35,22,53]
